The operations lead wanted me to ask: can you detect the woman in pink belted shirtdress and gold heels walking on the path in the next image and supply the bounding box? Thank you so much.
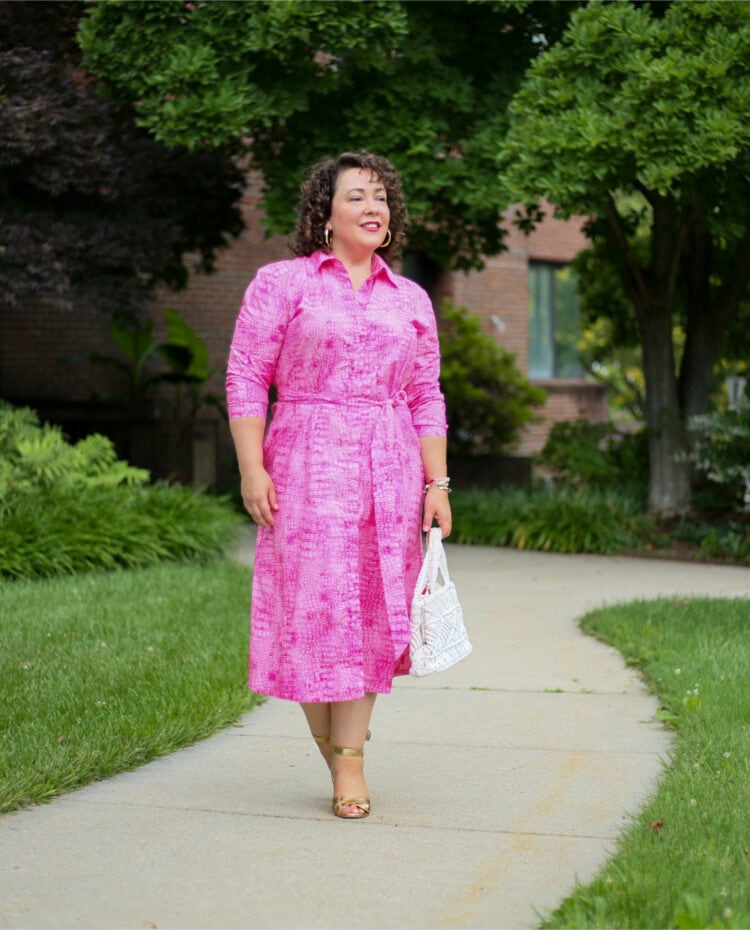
[227,152,451,819]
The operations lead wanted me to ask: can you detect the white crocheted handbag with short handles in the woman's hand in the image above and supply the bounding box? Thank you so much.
[409,527,471,678]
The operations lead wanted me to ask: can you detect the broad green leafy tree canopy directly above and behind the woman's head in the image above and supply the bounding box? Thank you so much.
[80,0,576,268]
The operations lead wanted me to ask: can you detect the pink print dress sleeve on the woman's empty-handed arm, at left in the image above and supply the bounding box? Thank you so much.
[226,262,291,419]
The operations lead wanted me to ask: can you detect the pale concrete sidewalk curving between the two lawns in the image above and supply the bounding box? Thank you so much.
[0,546,750,930]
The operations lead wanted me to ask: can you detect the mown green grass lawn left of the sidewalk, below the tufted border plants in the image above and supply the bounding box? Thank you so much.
[0,561,257,812]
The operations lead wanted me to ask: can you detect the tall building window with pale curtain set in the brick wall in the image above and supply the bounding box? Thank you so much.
[529,262,582,380]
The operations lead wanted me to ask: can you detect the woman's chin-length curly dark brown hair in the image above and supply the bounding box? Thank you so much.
[291,151,406,265]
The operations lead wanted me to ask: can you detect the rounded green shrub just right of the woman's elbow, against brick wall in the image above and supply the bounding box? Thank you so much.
[439,301,546,456]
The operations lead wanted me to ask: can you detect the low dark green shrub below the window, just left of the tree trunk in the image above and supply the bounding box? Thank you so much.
[538,420,648,495]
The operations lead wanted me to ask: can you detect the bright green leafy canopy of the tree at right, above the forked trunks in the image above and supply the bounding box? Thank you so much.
[503,2,750,209]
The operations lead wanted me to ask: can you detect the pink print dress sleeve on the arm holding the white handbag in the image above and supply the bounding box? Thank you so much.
[404,285,448,437]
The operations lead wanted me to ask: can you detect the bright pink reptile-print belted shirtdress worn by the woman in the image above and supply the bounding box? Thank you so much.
[227,252,446,701]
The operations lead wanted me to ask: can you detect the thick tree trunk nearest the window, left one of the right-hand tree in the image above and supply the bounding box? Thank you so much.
[638,305,690,517]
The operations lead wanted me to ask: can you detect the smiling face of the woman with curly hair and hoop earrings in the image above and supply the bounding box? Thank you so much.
[326,168,391,261]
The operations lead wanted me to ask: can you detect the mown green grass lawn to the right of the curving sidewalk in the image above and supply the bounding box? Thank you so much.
[543,598,750,928]
